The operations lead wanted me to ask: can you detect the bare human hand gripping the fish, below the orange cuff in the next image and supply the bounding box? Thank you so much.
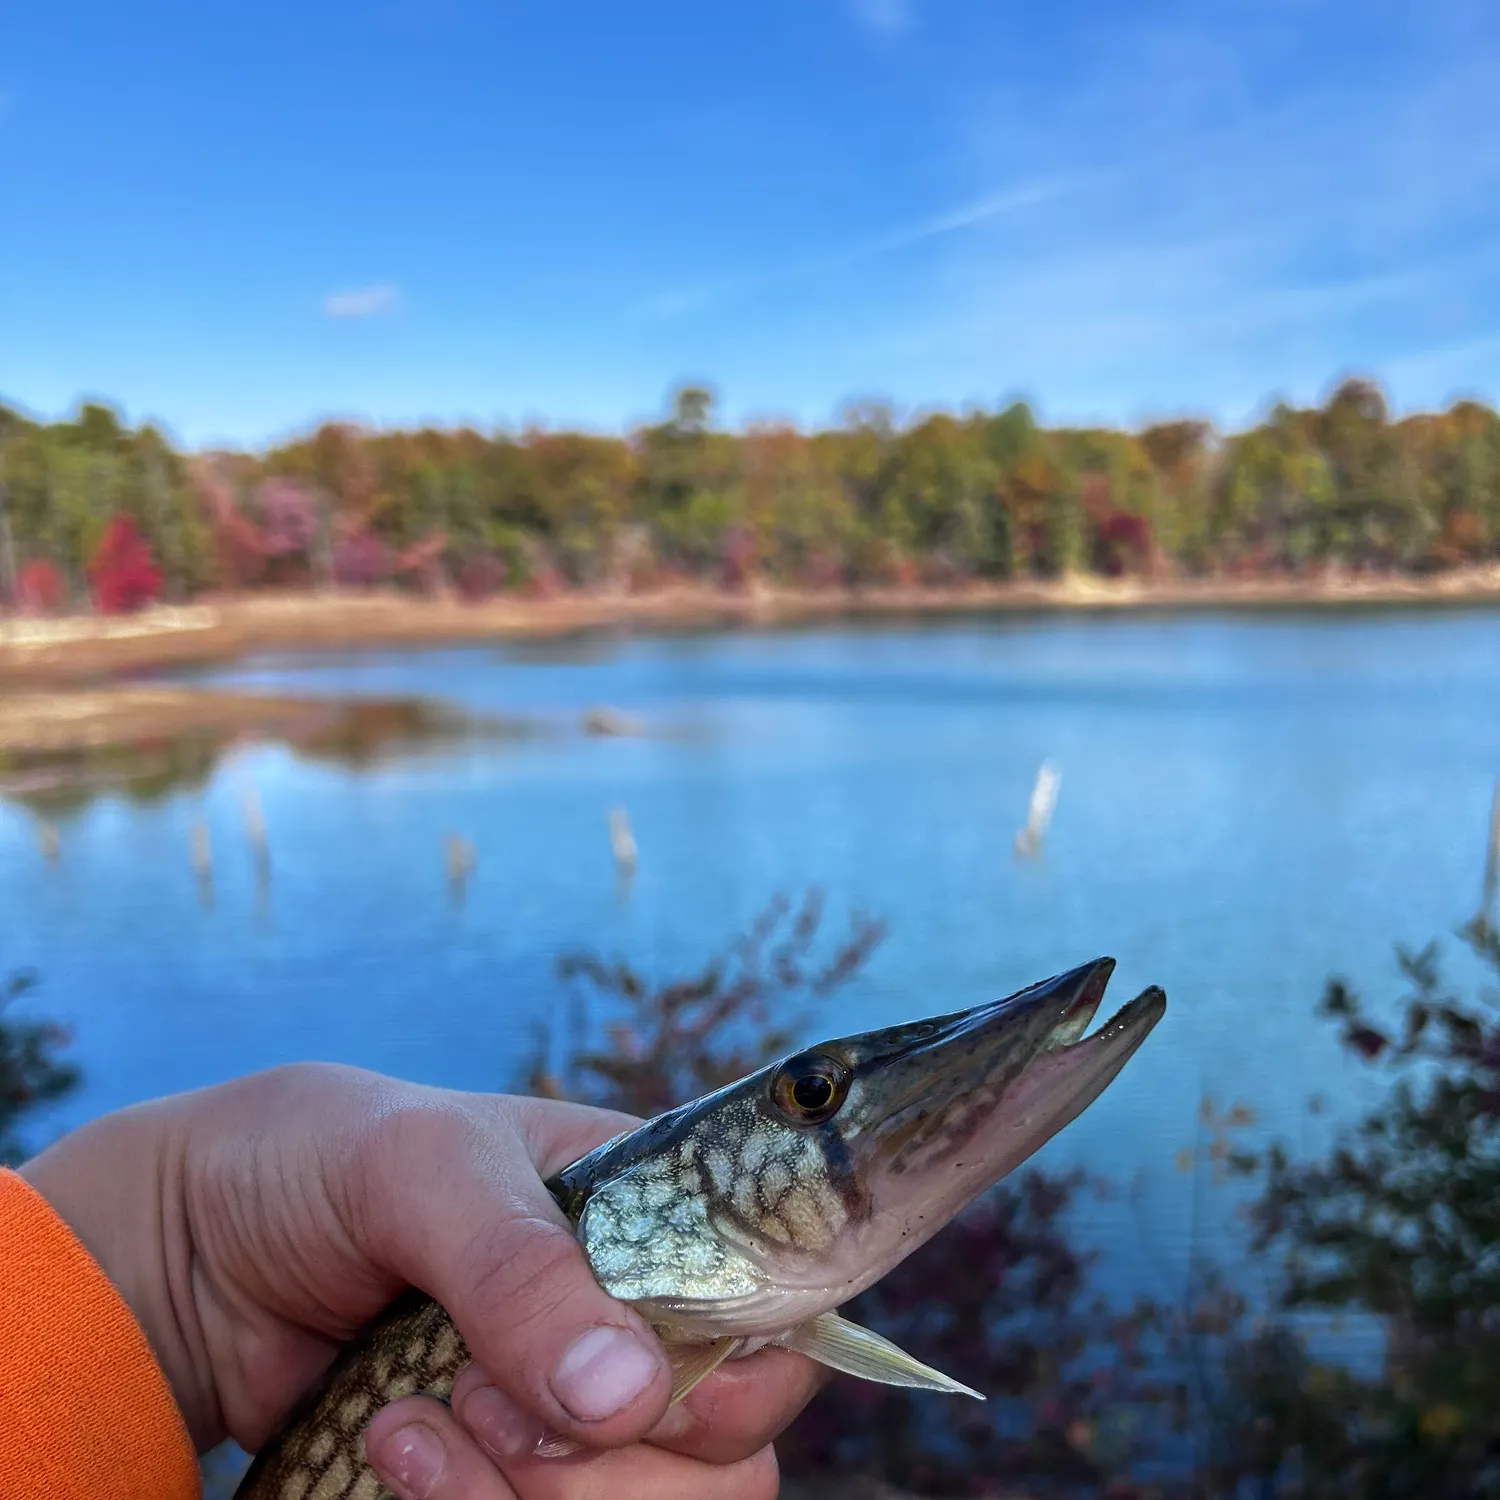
[23,1065,821,1500]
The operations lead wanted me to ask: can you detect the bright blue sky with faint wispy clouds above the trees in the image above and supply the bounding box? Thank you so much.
[0,0,1500,444]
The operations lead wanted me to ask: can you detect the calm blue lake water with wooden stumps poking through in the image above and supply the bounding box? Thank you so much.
[0,612,1500,1292]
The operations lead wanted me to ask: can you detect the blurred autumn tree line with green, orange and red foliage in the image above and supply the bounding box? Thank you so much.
[0,380,1500,609]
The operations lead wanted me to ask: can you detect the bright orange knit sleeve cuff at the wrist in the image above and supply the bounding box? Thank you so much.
[0,1172,201,1500]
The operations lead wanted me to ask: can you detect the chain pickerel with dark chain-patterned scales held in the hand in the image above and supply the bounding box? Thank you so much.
[236,959,1167,1500]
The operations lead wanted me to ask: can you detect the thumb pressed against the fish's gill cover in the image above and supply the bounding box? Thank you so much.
[354,1095,672,1448]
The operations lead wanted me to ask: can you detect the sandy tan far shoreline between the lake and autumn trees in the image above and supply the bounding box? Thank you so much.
[0,564,1500,690]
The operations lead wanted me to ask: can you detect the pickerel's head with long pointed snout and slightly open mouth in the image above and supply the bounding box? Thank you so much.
[554,959,1167,1337]
